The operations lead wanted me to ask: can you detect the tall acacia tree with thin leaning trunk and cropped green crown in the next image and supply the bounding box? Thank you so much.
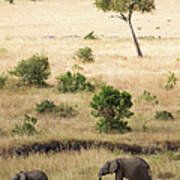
[95,0,155,57]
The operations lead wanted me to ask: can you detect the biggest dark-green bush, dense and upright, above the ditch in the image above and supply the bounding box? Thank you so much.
[90,86,133,133]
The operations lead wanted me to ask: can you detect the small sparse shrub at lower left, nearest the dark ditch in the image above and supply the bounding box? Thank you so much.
[11,114,38,136]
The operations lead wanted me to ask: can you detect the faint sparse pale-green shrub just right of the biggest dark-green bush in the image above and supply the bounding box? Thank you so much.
[135,90,159,105]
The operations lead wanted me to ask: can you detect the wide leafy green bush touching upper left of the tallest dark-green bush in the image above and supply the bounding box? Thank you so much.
[57,71,95,93]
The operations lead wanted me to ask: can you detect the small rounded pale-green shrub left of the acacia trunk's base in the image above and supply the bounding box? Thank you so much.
[74,47,94,63]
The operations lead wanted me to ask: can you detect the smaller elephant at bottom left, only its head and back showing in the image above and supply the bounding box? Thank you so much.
[12,170,48,180]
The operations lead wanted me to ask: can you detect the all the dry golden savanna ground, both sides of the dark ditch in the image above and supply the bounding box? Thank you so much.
[0,0,180,180]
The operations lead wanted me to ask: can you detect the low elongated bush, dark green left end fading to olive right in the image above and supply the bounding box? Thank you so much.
[36,100,77,117]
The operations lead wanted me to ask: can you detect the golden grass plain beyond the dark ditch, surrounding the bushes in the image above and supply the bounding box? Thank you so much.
[0,0,180,147]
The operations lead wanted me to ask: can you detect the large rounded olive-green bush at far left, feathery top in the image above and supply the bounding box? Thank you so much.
[10,54,50,86]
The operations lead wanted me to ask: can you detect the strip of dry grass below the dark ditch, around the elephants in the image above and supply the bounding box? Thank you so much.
[0,149,180,180]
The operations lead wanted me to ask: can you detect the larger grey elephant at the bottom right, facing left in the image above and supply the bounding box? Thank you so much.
[98,157,152,180]
